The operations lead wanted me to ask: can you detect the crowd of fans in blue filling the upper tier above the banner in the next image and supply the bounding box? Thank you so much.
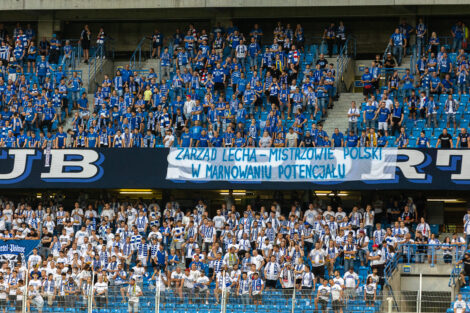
[0,21,469,148]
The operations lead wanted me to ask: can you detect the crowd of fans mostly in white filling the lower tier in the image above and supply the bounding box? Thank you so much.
[0,198,464,308]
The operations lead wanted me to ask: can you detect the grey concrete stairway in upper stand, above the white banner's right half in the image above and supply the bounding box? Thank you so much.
[323,92,364,137]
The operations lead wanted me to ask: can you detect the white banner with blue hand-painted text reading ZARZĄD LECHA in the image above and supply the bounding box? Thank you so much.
[166,148,397,182]
